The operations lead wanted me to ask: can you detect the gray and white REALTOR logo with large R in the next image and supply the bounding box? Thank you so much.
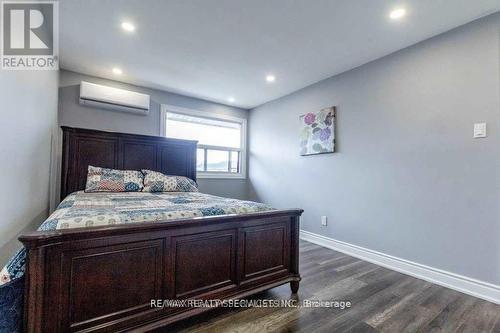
[1,1,59,70]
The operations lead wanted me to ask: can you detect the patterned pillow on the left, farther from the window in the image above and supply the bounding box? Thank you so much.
[85,165,144,192]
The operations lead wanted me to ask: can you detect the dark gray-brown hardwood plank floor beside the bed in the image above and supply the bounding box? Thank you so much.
[165,241,500,333]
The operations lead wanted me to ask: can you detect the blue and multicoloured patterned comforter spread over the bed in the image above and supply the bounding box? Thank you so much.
[0,191,272,333]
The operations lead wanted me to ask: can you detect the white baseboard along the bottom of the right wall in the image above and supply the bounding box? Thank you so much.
[300,230,500,304]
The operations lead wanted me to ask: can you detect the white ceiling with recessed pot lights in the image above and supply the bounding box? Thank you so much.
[60,0,500,108]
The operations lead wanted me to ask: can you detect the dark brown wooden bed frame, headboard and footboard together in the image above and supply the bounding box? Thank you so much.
[19,127,302,333]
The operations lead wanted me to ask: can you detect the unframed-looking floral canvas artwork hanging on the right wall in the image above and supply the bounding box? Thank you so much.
[300,106,336,156]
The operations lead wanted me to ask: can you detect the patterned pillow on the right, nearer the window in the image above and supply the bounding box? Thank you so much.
[142,170,198,192]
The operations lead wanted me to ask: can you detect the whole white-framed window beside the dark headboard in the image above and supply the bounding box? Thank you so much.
[161,105,246,178]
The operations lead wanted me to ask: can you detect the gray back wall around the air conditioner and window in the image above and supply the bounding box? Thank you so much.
[59,70,248,199]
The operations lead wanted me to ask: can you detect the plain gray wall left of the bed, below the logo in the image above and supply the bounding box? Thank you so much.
[0,70,58,267]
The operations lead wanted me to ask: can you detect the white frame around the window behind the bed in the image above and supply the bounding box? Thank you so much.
[160,104,247,179]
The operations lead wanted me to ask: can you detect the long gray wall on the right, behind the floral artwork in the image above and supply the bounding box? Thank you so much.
[249,14,500,284]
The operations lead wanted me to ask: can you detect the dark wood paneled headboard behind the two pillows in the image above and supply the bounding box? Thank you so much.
[61,126,197,200]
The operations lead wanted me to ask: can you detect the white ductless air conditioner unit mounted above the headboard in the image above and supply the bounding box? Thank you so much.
[80,81,149,116]
